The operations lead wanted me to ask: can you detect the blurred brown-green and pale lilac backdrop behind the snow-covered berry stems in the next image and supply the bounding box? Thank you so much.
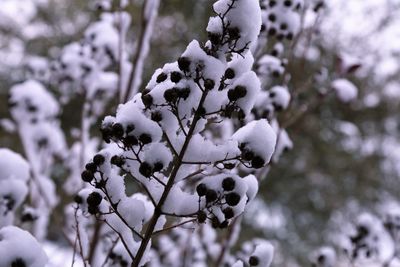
[0,0,400,266]
